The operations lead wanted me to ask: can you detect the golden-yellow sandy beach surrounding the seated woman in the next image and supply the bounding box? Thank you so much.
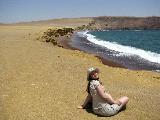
[0,23,160,120]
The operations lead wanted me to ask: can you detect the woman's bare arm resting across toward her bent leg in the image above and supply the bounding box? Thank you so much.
[96,85,121,105]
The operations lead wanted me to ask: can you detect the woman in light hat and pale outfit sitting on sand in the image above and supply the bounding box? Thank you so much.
[78,68,129,116]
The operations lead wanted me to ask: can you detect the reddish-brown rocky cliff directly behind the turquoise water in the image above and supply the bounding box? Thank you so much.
[90,16,160,29]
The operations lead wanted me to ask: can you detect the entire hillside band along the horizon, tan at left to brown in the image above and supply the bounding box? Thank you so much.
[3,16,160,30]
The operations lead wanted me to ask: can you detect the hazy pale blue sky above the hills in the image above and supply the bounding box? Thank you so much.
[0,0,160,23]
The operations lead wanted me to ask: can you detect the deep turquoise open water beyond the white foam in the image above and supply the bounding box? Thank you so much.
[90,30,160,54]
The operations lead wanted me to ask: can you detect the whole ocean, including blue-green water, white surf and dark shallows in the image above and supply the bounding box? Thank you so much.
[71,30,160,72]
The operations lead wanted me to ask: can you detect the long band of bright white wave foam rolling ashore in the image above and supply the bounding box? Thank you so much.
[78,31,160,63]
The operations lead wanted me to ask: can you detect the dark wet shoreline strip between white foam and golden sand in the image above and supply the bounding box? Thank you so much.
[59,31,159,72]
